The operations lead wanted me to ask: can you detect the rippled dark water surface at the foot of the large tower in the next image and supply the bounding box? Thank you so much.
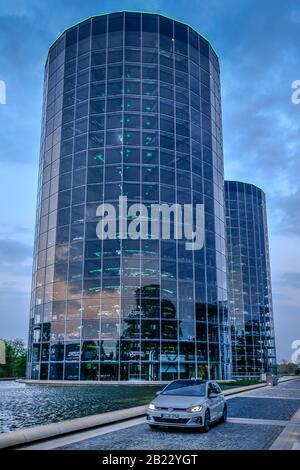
[0,381,162,433]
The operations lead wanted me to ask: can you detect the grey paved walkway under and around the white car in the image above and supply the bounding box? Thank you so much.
[22,379,300,450]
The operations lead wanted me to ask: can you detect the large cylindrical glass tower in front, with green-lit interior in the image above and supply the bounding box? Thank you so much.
[28,12,230,381]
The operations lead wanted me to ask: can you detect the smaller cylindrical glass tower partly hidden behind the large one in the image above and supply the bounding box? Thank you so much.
[225,181,276,377]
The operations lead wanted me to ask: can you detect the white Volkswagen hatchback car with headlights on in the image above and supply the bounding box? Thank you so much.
[147,379,227,432]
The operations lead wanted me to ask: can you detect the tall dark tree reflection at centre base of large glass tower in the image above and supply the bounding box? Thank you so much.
[121,284,180,380]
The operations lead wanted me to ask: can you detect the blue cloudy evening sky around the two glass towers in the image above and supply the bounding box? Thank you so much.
[0,0,300,361]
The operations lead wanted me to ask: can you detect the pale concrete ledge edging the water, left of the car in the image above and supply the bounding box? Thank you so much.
[0,405,147,449]
